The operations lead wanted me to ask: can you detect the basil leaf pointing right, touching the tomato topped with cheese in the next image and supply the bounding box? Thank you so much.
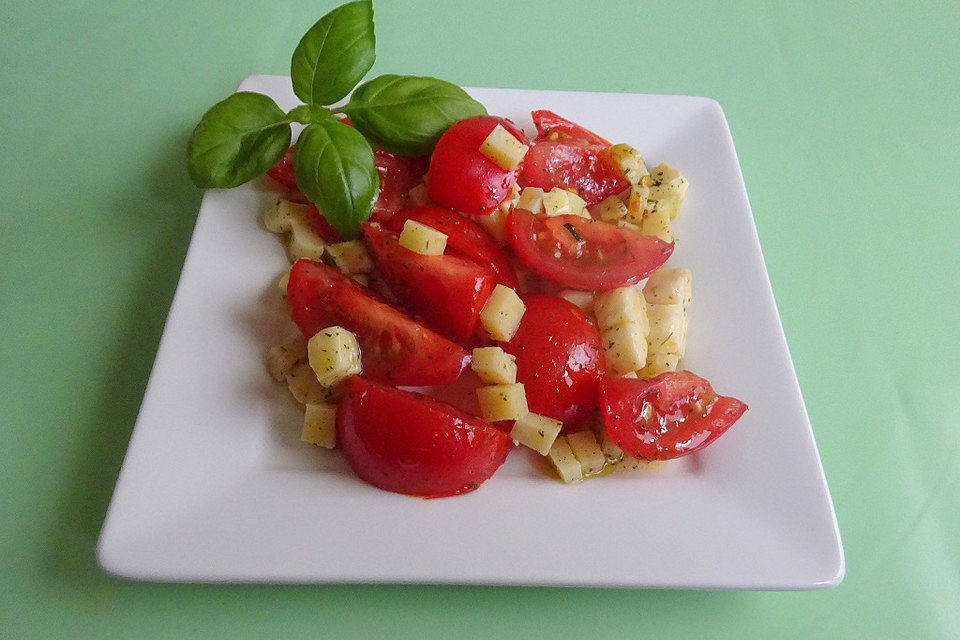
[342,75,487,155]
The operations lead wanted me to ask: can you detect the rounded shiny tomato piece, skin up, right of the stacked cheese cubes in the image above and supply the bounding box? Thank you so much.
[500,295,606,427]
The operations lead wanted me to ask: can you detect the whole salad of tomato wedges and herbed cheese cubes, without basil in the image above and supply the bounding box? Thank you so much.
[263,110,747,497]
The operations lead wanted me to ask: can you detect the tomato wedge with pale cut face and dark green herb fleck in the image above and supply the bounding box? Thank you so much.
[507,209,673,290]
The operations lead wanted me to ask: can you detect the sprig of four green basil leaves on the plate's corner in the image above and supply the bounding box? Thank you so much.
[187,0,486,238]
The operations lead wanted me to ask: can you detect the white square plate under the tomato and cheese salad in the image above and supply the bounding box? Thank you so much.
[99,76,844,589]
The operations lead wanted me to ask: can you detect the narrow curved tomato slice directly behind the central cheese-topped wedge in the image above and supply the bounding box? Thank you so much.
[387,207,517,289]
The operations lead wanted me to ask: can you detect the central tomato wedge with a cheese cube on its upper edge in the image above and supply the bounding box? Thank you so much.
[363,222,497,343]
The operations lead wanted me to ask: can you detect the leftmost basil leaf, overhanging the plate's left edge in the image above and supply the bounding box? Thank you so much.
[187,91,290,189]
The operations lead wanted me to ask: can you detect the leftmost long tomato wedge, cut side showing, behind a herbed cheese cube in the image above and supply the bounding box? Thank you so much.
[287,260,469,386]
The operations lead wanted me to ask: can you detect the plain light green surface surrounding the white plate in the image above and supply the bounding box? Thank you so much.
[0,0,960,638]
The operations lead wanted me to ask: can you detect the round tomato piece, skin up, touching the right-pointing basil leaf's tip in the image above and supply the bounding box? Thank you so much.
[427,116,527,215]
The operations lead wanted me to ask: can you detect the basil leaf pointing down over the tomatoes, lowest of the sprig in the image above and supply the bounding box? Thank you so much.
[293,118,380,239]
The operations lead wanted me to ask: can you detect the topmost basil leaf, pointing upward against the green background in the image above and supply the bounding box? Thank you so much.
[290,0,376,105]
